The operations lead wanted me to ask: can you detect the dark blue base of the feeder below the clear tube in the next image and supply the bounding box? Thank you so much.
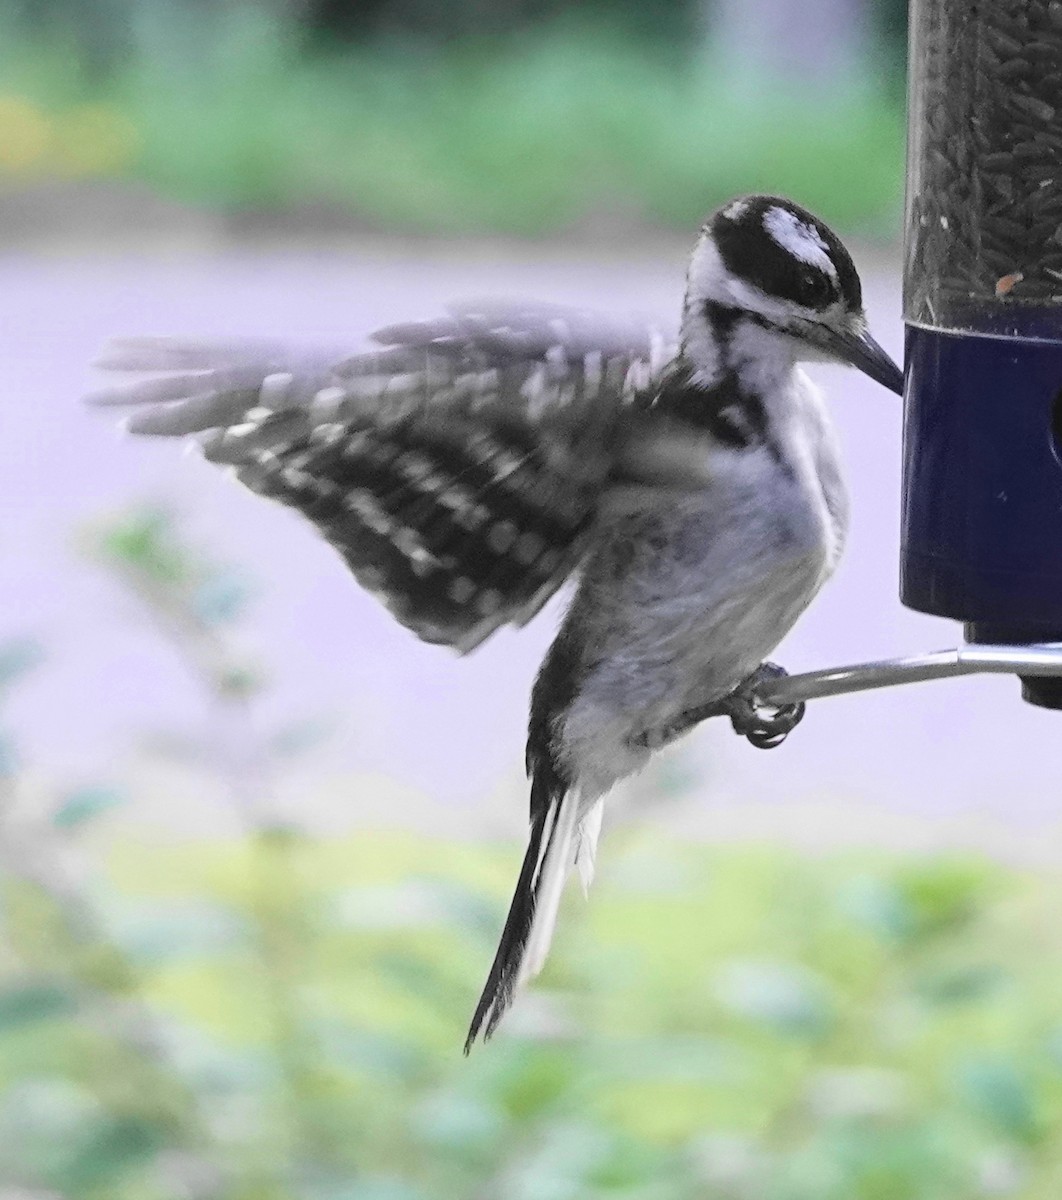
[900,321,1062,708]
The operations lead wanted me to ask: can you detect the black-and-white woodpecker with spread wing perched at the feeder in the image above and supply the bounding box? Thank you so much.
[90,196,902,1049]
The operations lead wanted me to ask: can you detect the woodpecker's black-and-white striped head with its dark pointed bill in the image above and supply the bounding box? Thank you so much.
[684,196,904,392]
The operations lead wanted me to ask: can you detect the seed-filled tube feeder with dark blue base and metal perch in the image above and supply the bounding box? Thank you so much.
[757,0,1062,708]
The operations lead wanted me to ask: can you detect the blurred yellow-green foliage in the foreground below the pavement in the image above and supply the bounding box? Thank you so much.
[0,508,1062,1200]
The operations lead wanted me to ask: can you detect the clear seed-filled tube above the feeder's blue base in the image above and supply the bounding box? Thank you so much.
[905,0,1062,332]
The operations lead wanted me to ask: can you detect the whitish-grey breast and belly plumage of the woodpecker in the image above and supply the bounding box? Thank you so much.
[562,377,847,794]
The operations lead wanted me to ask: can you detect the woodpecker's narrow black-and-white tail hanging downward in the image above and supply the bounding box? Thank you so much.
[464,779,601,1054]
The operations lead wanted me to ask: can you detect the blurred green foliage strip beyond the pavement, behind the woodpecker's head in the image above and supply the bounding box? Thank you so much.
[0,0,904,236]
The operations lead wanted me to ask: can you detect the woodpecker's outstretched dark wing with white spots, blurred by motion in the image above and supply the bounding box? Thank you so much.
[88,301,672,652]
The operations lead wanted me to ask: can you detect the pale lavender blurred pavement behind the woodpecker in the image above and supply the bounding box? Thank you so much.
[0,234,1062,847]
